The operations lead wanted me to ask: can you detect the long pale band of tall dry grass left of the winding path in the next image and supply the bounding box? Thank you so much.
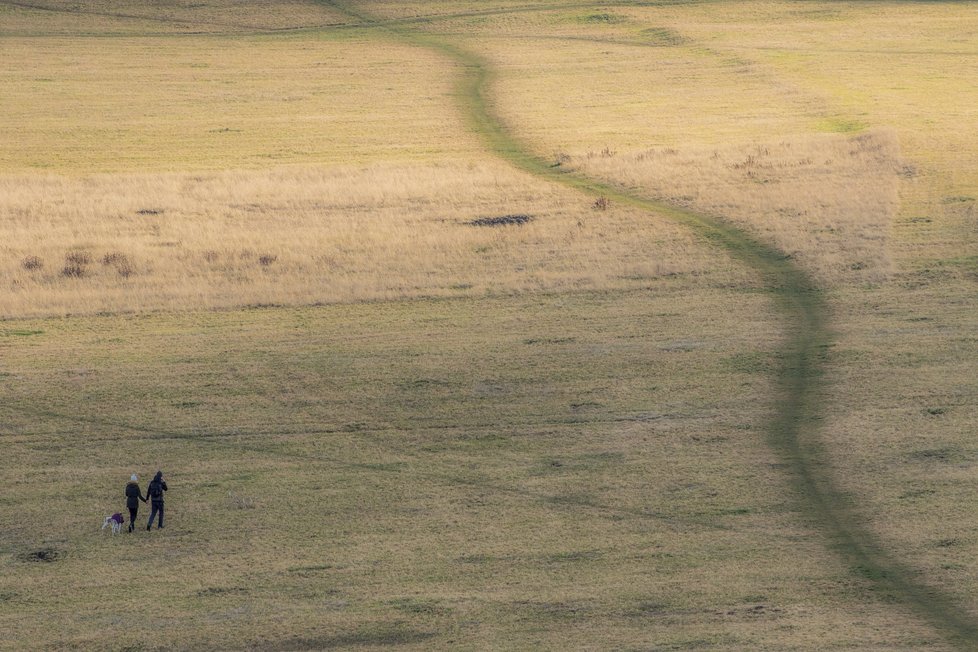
[0,164,743,317]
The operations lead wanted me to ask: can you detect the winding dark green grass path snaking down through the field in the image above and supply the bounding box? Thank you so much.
[325,2,978,650]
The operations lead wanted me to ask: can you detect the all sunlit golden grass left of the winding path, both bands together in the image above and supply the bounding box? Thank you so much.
[0,15,742,317]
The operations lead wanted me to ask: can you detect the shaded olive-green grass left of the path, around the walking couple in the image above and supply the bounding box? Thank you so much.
[2,288,941,649]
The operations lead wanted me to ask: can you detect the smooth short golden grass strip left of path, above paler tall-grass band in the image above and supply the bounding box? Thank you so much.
[0,32,478,175]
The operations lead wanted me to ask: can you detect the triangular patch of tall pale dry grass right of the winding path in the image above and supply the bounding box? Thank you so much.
[562,130,904,284]
